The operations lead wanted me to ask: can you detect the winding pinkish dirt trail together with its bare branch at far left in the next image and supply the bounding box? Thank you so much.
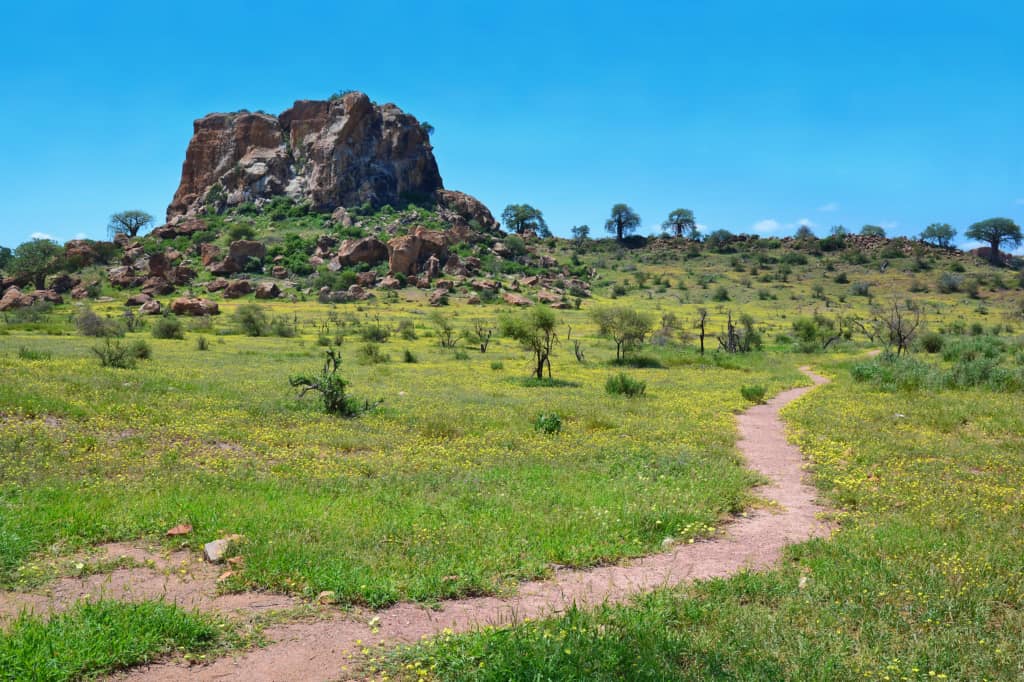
[0,368,829,682]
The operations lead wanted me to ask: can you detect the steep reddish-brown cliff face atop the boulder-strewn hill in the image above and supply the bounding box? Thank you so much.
[167,92,443,222]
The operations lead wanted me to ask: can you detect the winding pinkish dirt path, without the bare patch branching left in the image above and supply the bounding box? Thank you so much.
[99,368,828,682]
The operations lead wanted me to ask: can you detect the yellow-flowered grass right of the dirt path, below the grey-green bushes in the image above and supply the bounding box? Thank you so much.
[392,358,1024,681]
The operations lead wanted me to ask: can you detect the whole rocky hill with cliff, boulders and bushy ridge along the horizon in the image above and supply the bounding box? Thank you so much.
[0,92,1016,315]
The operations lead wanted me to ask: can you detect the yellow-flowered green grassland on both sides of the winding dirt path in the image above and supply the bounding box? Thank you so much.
[0,227,1024,680]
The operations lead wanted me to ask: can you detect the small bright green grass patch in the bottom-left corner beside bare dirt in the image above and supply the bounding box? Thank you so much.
[0,601,226,682]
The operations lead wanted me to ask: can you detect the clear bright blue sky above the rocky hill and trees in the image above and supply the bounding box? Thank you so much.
[0,0,1024,246]
